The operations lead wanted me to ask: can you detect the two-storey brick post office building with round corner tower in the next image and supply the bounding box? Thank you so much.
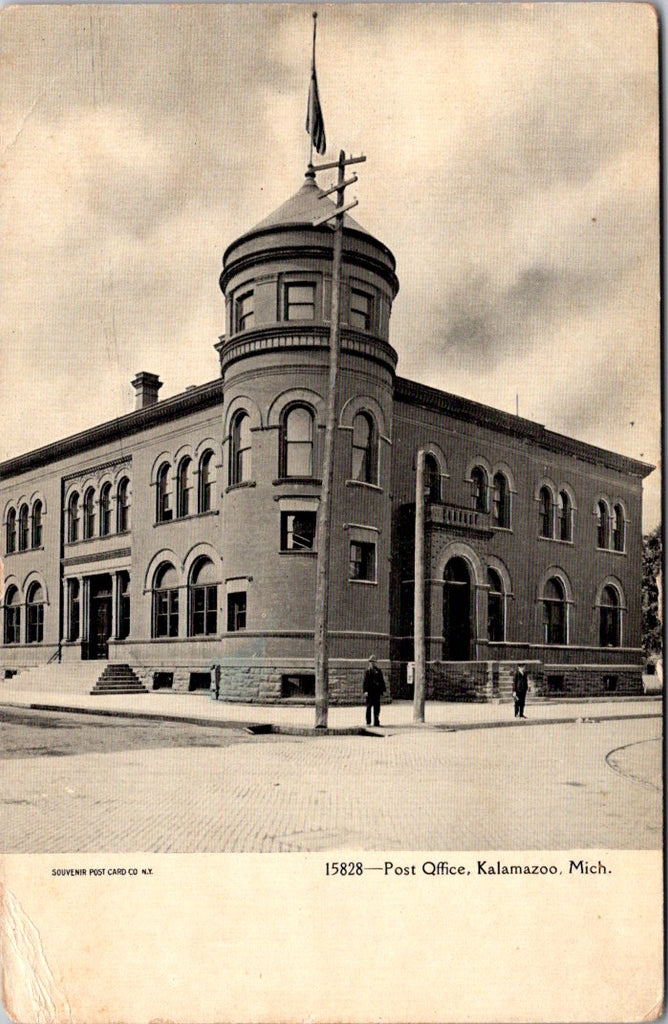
[0,173,652,701]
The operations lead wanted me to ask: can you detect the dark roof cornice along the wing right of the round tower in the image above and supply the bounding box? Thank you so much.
[394,377,656,479]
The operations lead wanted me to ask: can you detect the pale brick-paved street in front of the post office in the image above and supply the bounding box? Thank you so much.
[0,716,662,853]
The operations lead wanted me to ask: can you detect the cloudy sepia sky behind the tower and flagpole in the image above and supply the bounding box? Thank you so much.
[0,4,660,527]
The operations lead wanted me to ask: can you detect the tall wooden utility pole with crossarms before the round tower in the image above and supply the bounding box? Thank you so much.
[309,150,367,729]
